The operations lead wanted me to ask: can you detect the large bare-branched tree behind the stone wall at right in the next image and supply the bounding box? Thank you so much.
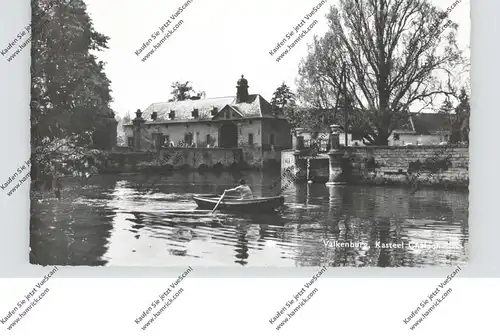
[297,0,463,145]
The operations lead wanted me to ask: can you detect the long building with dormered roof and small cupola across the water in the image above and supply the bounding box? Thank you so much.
[124,75,291,150]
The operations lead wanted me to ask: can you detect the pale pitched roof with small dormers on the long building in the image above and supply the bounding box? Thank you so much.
[142,94,284,123]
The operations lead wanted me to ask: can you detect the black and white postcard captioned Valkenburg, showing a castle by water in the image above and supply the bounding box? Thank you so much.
[23,0,471,268]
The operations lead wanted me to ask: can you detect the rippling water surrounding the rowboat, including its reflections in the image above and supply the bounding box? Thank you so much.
[30,172,469,267]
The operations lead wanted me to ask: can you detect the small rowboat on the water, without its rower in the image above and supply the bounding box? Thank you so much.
[193,194,285,212]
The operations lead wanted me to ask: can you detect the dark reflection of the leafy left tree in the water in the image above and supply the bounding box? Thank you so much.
[30,175,121,266]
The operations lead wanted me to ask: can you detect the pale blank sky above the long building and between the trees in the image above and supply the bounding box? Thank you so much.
[86,0,470,116]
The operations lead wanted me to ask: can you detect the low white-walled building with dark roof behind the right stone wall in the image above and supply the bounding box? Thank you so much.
[388,113,451,146]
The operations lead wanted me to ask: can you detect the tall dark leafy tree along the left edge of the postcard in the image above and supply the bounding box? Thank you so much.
[31,0,116,184]
